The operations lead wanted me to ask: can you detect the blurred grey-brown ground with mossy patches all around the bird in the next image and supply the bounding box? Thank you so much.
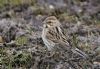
[0,0,100,69]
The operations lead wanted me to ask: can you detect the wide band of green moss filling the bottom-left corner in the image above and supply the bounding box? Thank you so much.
[0,51,32,69]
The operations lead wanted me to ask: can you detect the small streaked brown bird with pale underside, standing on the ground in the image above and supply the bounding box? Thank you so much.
[41,16,88,59]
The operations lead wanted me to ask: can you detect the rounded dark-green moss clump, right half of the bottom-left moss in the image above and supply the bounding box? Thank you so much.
[12,52,32,66]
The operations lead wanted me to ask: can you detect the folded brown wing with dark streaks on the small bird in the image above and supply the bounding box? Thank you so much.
[46,27,69,45]
